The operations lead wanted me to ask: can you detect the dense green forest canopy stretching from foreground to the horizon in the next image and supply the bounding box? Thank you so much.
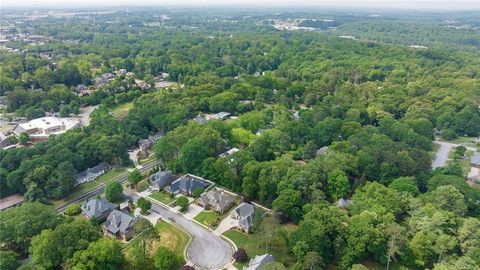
[0,7,480,270]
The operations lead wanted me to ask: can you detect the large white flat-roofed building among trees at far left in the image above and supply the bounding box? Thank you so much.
[13,116,80,141]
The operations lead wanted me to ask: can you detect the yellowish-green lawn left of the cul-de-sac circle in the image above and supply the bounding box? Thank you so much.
[124,221,190,269]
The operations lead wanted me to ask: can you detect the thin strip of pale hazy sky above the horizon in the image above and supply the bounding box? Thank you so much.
[0,0,480,10]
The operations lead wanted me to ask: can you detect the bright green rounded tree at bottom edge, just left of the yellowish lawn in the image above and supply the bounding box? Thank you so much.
[67,239,125,270]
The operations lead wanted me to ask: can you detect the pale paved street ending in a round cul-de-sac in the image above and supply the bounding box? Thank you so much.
[152,202,233,269]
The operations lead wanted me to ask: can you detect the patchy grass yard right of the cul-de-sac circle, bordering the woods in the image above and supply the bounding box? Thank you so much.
[223,225,295,267]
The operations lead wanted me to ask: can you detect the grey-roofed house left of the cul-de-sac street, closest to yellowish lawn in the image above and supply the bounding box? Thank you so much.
[102,210,135,241]
